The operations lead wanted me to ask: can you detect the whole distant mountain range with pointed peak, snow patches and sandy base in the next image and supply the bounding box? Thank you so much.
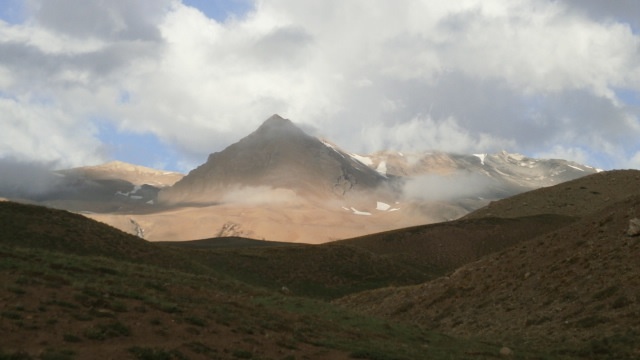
[0,115,598,243]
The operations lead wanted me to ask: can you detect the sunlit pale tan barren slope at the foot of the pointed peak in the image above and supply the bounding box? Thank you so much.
[85,198,464,244]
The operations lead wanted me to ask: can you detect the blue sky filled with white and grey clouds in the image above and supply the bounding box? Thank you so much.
[0,0,640,176]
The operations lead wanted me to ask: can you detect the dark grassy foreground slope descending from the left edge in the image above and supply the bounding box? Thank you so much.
[0,203,531,359]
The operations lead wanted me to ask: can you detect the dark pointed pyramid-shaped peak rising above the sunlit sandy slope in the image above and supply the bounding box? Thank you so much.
[158,115,389,204]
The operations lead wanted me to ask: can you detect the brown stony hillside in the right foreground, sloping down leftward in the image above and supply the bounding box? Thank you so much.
[338,191,640,358]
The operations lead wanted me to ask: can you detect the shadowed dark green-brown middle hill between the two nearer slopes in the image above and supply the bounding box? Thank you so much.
[161,215,575,299]
